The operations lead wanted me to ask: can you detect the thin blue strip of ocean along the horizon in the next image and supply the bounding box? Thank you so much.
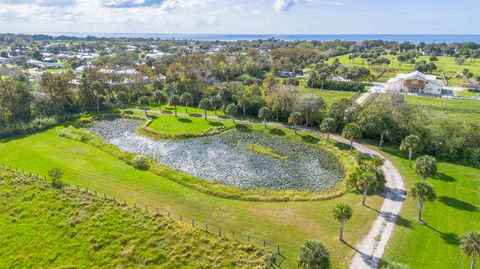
[30,32,480,44]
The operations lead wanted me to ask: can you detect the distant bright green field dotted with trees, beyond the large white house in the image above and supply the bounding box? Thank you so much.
[329,54,480,86]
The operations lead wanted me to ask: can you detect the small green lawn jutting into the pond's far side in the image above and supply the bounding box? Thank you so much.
[148,114,233,135]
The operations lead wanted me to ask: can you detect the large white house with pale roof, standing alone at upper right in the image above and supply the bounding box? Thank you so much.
[386,71,445,96]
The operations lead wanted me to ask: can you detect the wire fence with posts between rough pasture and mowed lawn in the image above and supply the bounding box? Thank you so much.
[1,163,285,268]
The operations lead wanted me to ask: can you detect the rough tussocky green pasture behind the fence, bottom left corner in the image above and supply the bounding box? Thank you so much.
[0,171,269,268]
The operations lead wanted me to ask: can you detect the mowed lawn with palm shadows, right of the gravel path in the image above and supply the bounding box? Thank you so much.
[377,148,480,269]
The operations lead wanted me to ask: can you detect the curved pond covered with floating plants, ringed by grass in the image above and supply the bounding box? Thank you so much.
[90,119,343,191]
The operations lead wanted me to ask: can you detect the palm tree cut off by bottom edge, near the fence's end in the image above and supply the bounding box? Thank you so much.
[298,240,330,269]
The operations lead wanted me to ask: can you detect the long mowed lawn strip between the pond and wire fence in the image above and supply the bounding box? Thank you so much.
[0,127,383,268]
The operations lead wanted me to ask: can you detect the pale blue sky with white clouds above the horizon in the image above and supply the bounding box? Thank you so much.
[0,0,480,34]
